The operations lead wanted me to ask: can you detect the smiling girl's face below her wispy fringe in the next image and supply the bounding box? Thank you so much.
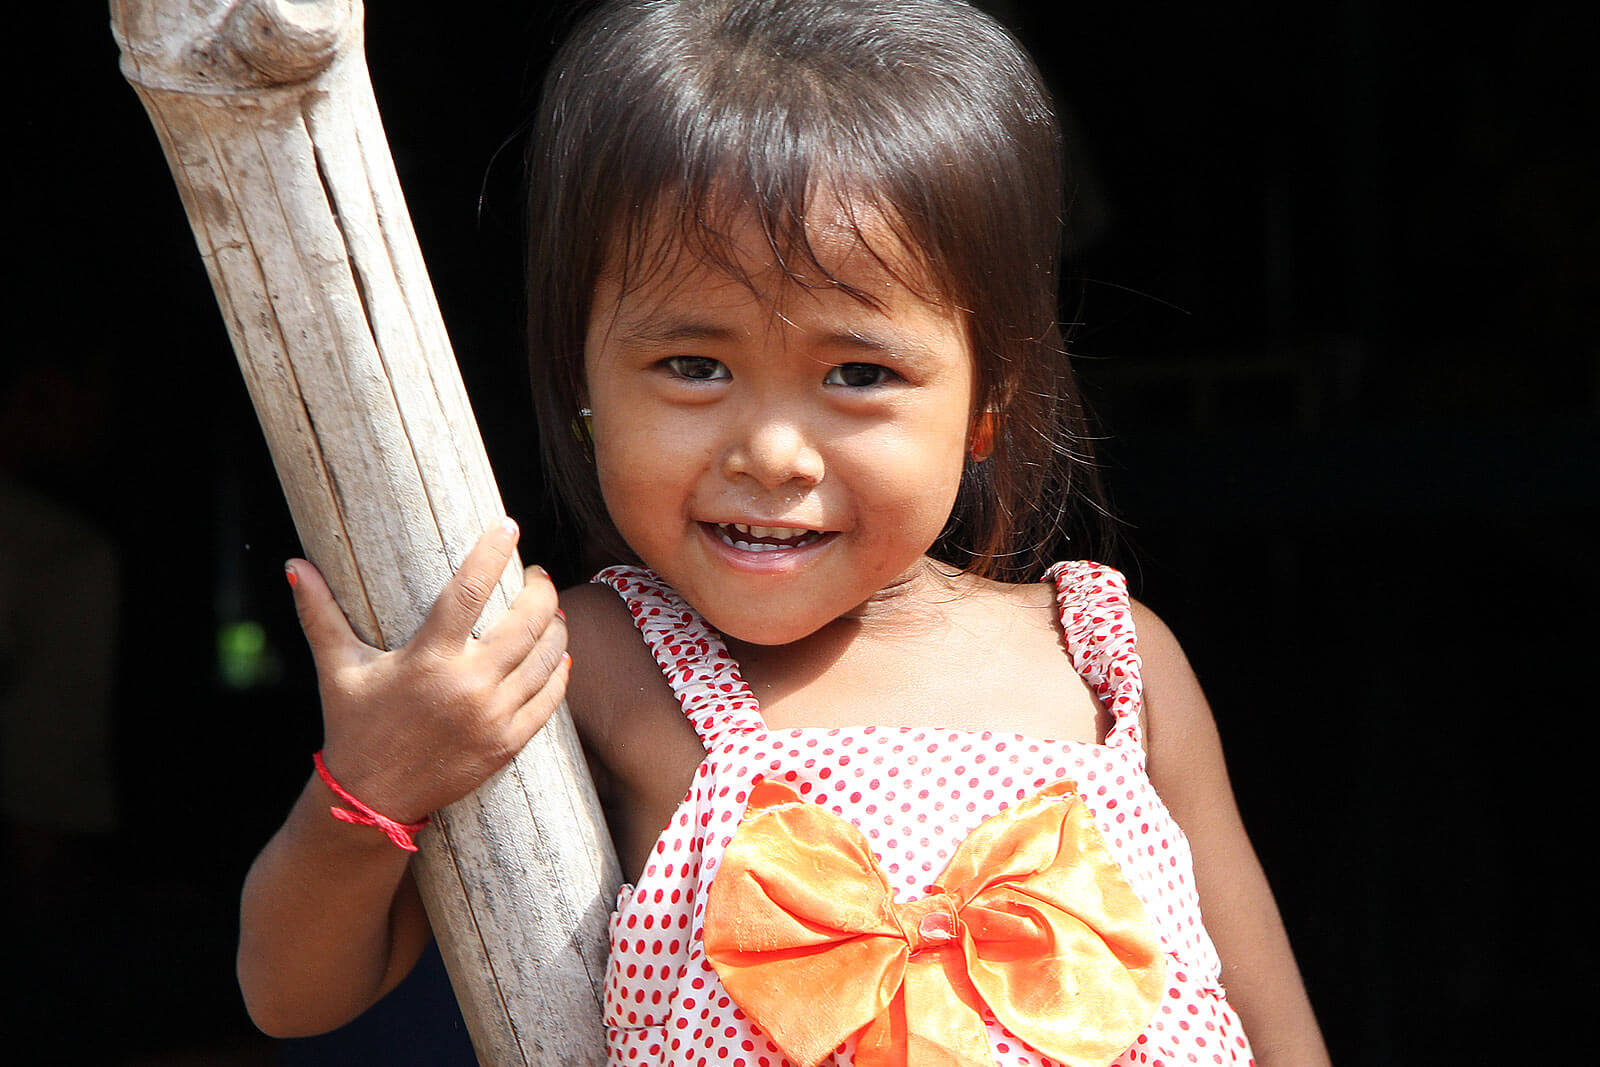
[584,206,974,645]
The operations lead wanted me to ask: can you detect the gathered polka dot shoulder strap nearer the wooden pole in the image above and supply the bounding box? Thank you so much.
[590,566,766,752]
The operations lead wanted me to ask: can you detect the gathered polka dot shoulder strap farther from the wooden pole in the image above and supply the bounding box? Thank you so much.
[1045,560,1144,749]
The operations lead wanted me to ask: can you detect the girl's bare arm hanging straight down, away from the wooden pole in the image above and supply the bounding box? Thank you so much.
[1134,605,1330,1067]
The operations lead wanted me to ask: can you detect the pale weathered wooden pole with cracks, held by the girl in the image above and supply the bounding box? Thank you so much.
[112,0,621,1064]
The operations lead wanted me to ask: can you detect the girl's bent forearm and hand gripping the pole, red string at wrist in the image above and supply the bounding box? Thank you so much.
[238,520,570,1037]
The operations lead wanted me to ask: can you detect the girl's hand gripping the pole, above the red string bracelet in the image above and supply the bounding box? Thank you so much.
[286,518,571,822]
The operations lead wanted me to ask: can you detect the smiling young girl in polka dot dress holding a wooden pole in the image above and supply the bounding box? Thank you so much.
[238,0,1325,1067]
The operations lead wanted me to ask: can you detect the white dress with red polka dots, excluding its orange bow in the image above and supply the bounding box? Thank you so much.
[595,563,1254,1067]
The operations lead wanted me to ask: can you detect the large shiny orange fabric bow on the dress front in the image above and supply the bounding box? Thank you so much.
[704,781,1165,1067]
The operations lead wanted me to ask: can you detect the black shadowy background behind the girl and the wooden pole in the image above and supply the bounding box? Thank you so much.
[0,0,1600,1064]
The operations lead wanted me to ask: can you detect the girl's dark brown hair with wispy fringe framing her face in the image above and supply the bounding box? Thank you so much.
[528,0,1102,581]
